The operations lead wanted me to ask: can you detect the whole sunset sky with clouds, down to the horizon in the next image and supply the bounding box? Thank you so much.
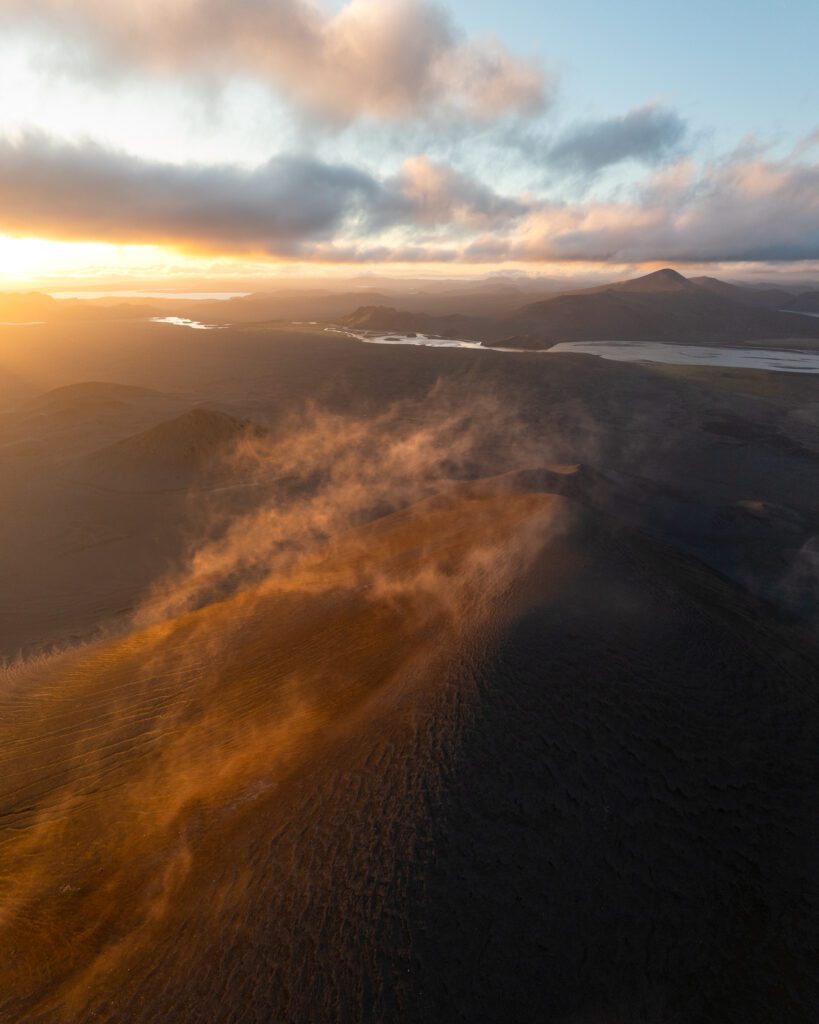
[0,0,819,289]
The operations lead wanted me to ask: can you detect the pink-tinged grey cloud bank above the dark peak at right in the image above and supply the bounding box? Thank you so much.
[465,152,819,263]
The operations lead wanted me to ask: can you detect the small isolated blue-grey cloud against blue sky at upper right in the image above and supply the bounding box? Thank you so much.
[544,104,687,174]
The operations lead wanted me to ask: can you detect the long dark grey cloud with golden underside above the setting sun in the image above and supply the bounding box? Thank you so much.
[0,136,382,251]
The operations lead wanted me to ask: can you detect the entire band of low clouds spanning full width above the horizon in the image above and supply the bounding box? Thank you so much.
[0,135,819,263]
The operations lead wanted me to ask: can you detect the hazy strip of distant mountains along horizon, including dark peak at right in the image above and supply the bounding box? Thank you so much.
[7,267,819,337]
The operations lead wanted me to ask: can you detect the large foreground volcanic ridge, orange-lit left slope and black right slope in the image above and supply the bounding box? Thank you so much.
[0,477,819,1024]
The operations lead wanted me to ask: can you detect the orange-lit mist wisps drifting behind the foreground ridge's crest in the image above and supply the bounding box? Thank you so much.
[136,388,561,624]
